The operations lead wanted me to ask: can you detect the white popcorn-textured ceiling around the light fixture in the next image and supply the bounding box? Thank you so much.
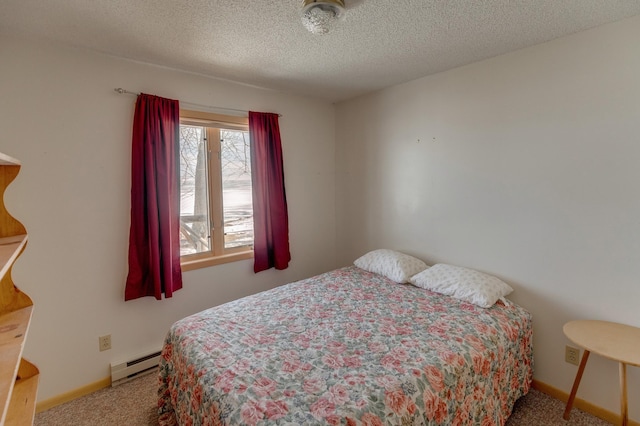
[0,0,640,101]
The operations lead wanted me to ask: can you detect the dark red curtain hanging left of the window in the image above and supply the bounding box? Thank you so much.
[124,94,182,300]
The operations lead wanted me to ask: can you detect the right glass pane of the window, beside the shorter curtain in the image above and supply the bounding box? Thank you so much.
[220,130,253,248]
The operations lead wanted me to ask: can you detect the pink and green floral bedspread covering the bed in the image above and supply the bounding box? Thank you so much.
[158,266,533,426]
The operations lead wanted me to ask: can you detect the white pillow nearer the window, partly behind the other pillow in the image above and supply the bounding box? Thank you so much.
[353,249,428,283]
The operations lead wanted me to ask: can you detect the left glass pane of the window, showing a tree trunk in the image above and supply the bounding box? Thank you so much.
[180,125,211,256]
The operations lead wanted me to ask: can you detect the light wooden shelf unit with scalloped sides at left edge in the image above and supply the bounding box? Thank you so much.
[0,153,39,426]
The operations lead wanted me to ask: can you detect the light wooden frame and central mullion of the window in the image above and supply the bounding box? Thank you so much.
[180,109,253,271]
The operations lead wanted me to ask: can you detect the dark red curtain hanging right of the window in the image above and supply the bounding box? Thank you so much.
[249,111,291,272]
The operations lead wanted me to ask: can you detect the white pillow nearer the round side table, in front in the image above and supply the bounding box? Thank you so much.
[409,263,513,308]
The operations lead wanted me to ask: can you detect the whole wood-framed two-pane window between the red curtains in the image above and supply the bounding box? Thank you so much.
[180,110,253,270]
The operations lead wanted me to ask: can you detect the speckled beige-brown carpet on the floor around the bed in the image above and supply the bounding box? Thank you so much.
[34,374,610,426]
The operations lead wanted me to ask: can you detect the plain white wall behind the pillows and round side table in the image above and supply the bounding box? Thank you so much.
[336,17,640,419]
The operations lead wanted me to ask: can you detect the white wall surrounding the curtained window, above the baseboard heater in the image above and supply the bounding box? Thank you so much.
[0,39,335,401]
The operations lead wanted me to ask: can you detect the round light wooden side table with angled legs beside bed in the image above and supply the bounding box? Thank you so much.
[562,320,640,426]
